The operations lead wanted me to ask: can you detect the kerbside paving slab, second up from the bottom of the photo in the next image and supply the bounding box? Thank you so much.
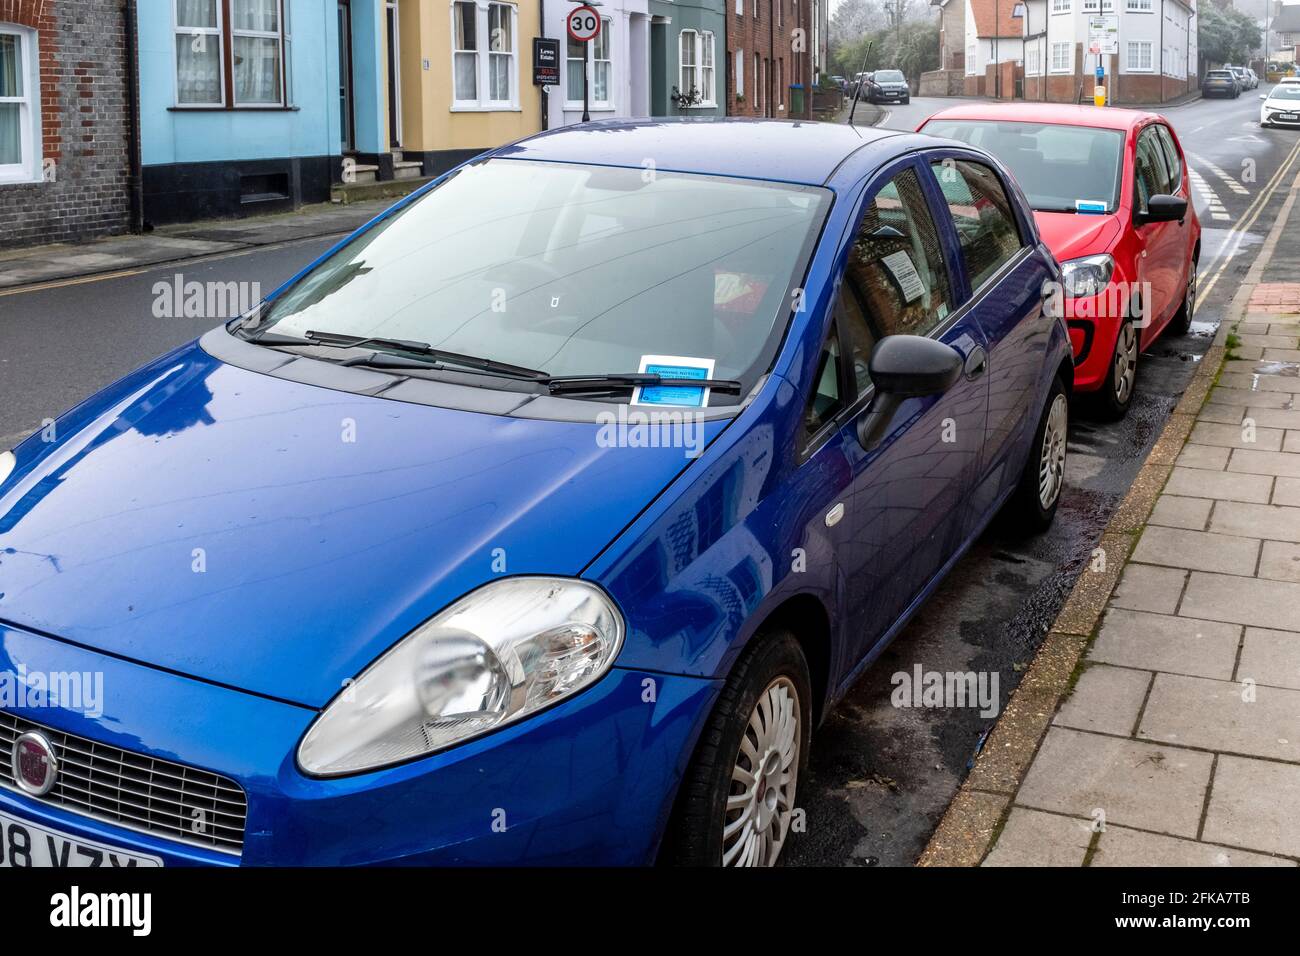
[1017,727,1211,836]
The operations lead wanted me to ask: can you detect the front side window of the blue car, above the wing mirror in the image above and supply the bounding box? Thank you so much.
[840,169,953,353]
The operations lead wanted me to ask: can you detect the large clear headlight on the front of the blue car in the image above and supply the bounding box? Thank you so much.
[298,578,624,777]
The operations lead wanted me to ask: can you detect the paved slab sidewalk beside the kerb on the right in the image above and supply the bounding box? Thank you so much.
[984,295,1300,866]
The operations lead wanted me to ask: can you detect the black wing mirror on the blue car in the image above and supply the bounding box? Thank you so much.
[858,336,966,451]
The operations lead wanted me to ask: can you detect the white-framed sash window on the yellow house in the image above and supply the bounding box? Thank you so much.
[451,0,514,109]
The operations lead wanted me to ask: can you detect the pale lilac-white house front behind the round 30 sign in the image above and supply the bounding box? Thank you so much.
[545,0,650,129]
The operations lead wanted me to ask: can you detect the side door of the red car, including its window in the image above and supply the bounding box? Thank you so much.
[1134,125,1184,349]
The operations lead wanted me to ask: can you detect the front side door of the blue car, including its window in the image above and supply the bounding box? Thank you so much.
[813,159,988,674]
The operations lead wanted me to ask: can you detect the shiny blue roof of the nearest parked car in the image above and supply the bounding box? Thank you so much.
[490,117,902,186]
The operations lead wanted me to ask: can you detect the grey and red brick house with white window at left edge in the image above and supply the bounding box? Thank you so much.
[0,0,137,247]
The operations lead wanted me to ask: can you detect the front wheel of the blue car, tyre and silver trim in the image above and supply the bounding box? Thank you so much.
[660,630,813,866]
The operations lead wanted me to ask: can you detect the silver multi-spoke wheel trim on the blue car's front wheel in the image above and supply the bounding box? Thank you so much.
[722,676,803,866]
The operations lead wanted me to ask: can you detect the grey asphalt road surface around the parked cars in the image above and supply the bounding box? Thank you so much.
[0,94,1297,865]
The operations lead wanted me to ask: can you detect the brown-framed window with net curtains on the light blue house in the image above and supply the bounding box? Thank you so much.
[173,0,293,109]
